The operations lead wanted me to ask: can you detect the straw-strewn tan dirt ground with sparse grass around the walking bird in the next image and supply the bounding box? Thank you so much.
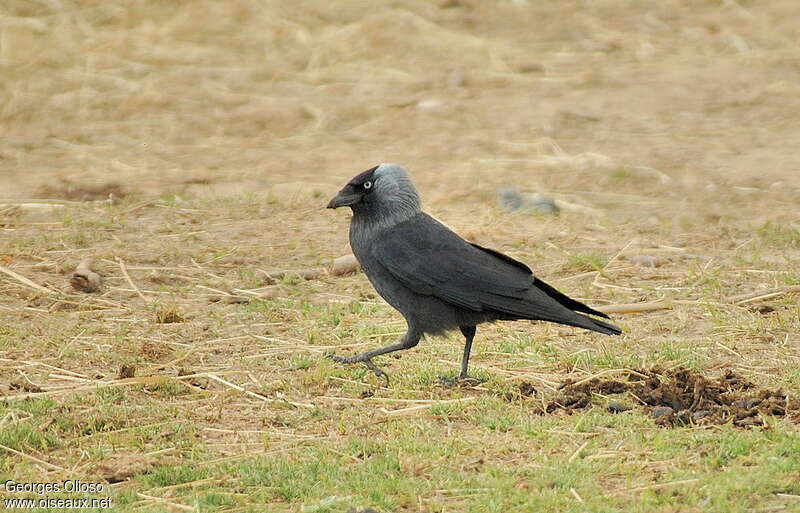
[0,0,800,512]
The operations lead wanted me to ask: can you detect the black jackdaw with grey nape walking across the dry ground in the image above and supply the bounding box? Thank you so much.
[328,164,622,380]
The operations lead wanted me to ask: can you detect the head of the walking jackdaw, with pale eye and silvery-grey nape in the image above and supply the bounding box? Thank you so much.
[328,163,421,220]
